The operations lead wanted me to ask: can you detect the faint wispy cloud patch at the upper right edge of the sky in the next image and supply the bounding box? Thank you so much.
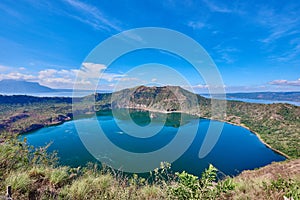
[255,5,300,64]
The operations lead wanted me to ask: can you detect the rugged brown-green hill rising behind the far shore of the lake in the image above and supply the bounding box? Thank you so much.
[96,86,208,112]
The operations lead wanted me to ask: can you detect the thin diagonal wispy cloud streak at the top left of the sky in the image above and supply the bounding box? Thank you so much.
[65,0,122,32]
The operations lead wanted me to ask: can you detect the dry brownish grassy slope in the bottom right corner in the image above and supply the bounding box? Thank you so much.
[224,159,300,200]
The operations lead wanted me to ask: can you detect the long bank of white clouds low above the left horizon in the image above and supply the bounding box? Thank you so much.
[0,63,139,89]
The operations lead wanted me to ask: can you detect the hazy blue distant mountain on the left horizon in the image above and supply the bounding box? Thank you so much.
[0,79,56,94]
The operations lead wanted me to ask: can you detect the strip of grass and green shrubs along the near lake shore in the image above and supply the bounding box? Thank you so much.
[0,138,300,200]
